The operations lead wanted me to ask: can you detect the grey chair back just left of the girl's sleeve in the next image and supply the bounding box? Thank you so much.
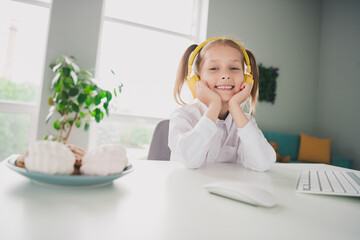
[147,119,171,161]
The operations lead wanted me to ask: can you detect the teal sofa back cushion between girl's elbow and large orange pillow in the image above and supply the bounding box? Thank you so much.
[263,131,300,160]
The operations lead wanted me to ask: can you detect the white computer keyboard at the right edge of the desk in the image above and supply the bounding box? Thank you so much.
[296,169,360,197]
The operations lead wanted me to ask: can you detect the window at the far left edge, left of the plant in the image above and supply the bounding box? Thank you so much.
[0,0,51,160]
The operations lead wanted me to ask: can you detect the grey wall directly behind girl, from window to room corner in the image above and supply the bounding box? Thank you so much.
[208,0,321,134]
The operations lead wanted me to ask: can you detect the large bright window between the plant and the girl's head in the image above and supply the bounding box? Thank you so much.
[89,0,207,159]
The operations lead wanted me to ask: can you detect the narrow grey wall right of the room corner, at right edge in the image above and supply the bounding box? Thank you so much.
[316,0,360,169]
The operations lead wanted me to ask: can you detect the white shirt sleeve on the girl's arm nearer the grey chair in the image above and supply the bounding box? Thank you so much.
[169,110,217,168]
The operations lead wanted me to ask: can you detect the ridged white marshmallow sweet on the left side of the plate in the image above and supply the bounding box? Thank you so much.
[24,141,75,175]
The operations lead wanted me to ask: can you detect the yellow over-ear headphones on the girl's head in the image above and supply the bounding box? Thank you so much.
[186,37,254,98]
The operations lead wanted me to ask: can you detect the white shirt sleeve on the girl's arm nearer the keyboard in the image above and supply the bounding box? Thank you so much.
[237,116,276,172]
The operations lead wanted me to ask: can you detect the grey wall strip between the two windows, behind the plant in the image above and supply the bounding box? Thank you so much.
[37,0,103,149]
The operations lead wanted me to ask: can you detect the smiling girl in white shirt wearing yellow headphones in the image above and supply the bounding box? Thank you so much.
[169,38,276,171]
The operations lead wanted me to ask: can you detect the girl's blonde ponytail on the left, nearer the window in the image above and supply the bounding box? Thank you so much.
[174,44,197,105]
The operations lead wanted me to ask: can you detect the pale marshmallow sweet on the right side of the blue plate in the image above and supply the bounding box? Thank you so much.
[80,144,128,176]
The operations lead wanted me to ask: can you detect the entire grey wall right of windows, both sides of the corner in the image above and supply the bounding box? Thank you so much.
[207,0,360,169]
